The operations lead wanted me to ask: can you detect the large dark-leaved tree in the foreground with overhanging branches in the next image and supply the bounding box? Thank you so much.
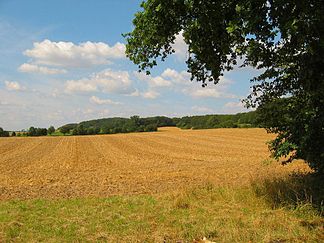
[124,0,324,173]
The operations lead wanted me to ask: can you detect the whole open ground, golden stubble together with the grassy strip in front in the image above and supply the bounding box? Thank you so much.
[0,128,324,242]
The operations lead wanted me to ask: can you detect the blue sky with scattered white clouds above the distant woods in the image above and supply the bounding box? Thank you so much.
[0,0,257,130]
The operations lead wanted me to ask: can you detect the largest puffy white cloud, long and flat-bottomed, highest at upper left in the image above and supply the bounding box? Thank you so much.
[24,39,125,68]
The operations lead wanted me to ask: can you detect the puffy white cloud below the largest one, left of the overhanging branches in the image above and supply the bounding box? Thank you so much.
[65,69,135,94]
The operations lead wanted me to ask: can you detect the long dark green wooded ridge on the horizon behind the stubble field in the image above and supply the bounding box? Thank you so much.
[58,111,260,135]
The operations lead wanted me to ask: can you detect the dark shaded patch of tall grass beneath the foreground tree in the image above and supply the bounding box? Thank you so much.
[252,173,324,216]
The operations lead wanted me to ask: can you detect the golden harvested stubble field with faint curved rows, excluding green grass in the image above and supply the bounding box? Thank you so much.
[0,128,307,200]
